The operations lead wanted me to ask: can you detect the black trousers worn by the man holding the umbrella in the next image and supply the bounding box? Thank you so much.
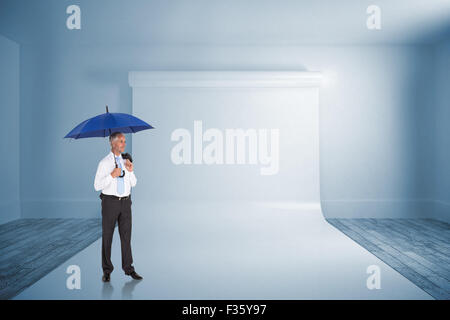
[102,197,134,274]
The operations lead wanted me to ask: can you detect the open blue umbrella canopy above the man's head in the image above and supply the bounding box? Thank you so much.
[64,106,154,139]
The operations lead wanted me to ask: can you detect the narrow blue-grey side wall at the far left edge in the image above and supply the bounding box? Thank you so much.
[0,35,20,223]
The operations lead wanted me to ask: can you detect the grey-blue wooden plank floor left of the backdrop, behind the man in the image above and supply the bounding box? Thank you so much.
[0,219,102,299]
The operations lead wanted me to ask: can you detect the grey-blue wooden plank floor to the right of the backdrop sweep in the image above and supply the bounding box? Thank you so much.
[327,219,450,300]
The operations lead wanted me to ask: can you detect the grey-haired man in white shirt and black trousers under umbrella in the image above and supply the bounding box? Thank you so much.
[94,132,142,282]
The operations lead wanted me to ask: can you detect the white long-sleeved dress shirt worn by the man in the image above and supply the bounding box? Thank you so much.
[94,151,137,197]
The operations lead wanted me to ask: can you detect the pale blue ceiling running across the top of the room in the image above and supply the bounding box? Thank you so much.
[0,0,450,45]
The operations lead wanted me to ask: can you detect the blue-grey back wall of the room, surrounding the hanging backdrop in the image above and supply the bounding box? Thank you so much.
[17,45,433,217]
